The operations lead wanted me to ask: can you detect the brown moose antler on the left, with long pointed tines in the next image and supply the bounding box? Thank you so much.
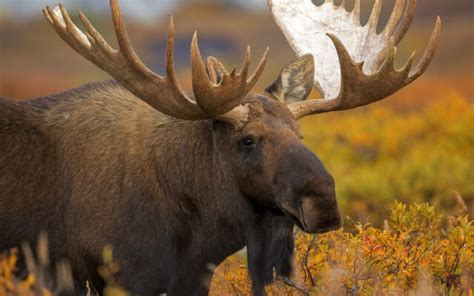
[43,0,268,120]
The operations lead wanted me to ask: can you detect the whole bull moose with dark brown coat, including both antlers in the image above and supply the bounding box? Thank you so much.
[0,0,441,295]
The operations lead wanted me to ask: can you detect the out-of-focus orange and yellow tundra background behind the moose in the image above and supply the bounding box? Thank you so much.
[0,0,474,225]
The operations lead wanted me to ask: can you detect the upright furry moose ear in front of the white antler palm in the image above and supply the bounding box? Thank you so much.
[265,54,314,103]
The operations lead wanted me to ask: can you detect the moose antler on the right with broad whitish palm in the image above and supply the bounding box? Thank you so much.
[268,0,441,119]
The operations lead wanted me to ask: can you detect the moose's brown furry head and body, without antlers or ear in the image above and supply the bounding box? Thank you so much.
[0,56,340,295]
